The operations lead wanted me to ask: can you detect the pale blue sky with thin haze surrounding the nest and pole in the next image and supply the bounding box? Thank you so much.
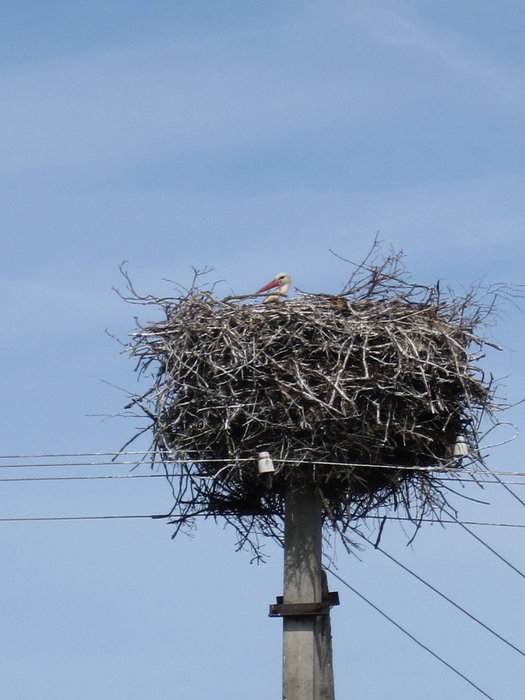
[0,0,525,700]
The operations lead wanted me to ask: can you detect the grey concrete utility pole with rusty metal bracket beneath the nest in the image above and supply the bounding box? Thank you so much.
[270,489,338,700]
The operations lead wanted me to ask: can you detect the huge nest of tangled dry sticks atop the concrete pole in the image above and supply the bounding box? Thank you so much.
[118,249,504,552]
